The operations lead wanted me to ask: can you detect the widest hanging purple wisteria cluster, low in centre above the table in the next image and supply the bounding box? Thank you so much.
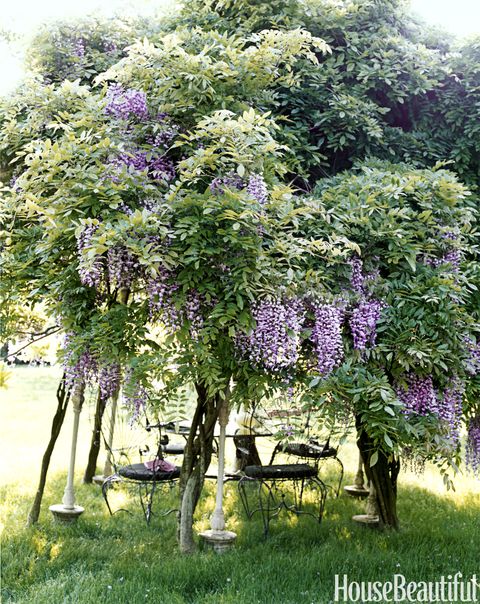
[237,298,305,373]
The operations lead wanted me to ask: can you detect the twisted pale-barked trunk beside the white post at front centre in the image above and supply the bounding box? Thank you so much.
[178,384,220,553]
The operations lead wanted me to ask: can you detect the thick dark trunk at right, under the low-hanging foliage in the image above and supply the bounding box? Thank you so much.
[356,416,400,529]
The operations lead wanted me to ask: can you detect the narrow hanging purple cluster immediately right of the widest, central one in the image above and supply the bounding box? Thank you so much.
[311,304,343,376]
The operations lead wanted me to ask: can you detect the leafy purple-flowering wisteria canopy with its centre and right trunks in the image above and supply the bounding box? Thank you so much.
[0,1,480,551]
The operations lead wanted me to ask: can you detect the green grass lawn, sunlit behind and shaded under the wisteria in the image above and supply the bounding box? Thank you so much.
[0,368,480,604]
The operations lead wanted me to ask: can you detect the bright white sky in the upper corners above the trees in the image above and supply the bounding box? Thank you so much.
[0,0,480,94]
